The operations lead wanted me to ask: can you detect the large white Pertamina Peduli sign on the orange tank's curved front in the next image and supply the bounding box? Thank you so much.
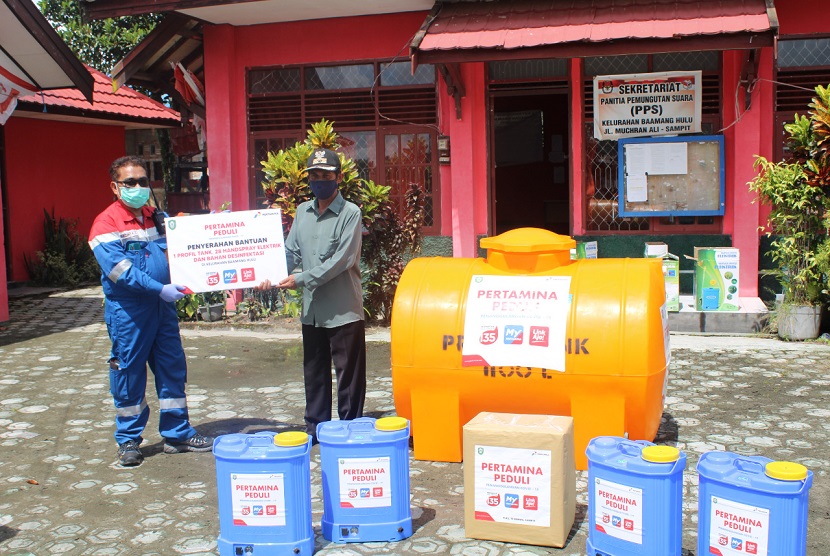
[461,275,571,372]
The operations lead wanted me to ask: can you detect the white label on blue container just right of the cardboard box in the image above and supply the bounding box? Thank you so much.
[591,477,643,544]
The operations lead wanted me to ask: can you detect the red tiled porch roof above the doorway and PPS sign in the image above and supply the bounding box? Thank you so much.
[413,0,771,58]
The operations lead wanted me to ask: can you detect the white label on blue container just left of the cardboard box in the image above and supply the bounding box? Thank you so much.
[337,457,392,508]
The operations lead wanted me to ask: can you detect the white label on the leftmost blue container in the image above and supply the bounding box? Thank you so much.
[231,473,286,527]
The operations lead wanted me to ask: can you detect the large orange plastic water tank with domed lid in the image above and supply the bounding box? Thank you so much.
[391,228,669,469]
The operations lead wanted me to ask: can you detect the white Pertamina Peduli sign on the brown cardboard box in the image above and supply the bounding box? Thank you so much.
[475,445,551,527]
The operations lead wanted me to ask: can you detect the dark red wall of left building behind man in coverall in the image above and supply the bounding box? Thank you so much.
[4,116,125,281]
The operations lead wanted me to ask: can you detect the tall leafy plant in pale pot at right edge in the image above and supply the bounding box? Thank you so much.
[749,86,830,340]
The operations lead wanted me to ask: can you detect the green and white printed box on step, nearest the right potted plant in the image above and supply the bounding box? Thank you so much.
[694,247,741,311]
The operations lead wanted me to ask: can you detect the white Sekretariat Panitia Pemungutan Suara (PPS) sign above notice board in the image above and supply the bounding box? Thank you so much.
[594,71,703,141]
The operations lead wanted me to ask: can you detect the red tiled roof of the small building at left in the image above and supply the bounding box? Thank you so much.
[18,66,180,125]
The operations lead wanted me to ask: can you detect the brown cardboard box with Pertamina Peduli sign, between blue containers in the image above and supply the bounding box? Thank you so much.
[464,412,576,547]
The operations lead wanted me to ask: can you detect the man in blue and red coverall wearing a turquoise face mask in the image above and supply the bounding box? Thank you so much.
[89,156,214,466]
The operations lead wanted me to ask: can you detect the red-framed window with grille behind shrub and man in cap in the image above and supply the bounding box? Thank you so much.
[248,61,440,234]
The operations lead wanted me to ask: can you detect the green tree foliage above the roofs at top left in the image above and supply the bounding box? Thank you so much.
[37,0,162,74]
